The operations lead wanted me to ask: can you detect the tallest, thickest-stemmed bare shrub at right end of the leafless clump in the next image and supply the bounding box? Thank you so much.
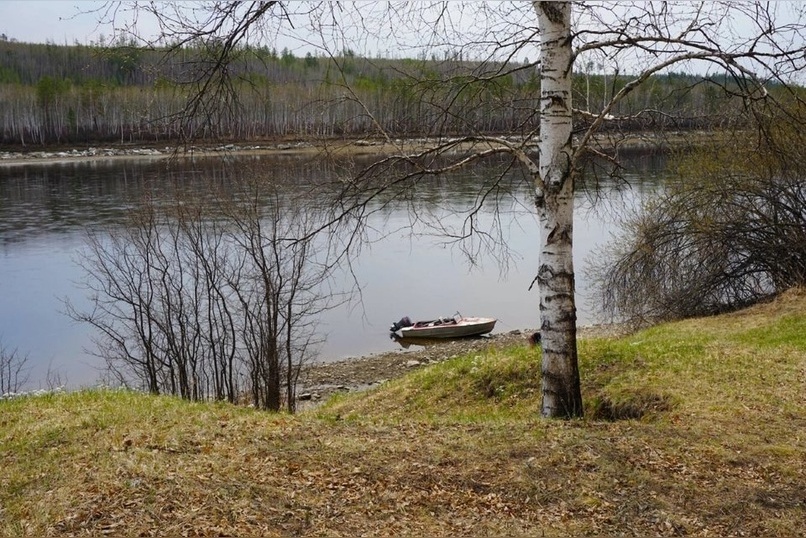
[219,173,340,412]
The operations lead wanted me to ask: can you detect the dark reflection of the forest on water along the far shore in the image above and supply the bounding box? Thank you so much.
[0,152,654,240]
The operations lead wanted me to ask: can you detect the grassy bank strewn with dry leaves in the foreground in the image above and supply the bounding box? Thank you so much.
[0,291,806,536]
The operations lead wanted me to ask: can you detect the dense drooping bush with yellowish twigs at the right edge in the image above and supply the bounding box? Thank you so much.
[591,103,806,324]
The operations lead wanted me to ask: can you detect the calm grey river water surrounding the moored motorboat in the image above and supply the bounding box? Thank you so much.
[0,156,661,389]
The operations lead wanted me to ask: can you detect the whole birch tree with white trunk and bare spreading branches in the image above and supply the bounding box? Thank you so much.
[104,2,806,417]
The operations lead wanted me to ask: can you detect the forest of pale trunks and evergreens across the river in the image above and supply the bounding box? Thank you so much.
[0,36,788,147]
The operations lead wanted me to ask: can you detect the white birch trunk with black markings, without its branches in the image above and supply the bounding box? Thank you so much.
[534,2,583,418]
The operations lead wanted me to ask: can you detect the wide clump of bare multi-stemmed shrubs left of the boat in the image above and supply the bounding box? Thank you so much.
[70,163,337,412]
